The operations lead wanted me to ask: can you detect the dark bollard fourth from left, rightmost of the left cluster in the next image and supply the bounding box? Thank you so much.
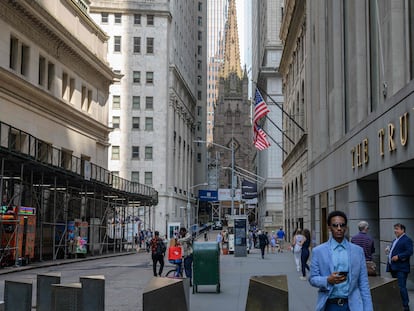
[79,275,105,311]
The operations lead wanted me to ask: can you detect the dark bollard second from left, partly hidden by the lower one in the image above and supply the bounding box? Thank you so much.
[36,273,61,311]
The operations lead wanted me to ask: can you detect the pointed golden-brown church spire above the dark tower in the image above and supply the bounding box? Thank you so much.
[221,0,243,78]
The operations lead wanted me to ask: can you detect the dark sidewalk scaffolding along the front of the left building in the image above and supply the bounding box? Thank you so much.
[0,122,158,262]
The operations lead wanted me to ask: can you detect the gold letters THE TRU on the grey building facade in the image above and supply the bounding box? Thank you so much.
[351,112,414,169]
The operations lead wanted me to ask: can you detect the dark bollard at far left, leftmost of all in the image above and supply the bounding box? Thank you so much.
[4,280,33,311]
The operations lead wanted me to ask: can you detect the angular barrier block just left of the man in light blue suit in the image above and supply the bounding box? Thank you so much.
[246,275,289,311]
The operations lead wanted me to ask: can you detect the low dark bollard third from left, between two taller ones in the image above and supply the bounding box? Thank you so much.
[52,283,82,311]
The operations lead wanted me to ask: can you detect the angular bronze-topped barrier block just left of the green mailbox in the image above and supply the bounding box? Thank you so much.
[142,277,190,311]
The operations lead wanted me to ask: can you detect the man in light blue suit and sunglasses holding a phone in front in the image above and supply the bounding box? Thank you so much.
[309,211,373,311]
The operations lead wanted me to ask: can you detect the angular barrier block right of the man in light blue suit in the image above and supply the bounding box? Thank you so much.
[368,276,402,311]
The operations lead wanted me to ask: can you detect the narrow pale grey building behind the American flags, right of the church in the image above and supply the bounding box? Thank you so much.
[252,0,286,230]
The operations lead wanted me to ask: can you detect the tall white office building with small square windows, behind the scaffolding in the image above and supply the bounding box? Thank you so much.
[91,0,207,233]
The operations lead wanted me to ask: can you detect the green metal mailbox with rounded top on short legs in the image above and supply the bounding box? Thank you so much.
[193,242,220,294]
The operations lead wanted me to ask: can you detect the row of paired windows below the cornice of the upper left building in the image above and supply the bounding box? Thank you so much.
[9,36,92,111]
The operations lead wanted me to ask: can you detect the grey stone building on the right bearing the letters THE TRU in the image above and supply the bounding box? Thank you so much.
[281,0,414,288]
